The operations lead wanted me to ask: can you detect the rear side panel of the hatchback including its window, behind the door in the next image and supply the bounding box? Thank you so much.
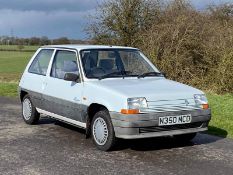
[20,49,54,108]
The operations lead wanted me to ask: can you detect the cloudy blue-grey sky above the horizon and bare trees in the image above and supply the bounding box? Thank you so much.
[0,0,233,39]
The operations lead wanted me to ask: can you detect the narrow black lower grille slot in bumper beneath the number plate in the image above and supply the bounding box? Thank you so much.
[139,122,206,133]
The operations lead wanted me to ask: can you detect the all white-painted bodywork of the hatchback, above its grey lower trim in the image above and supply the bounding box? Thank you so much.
[20,45,204,123]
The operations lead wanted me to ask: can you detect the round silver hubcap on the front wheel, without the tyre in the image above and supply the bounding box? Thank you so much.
[93,117,108,145]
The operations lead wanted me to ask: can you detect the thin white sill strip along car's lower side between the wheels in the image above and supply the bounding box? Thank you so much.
[36,108,86,128]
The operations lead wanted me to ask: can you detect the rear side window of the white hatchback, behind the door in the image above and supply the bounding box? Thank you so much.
[28,49,54,75]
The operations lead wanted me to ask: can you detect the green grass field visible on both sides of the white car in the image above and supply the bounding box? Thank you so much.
[0,46,233,138]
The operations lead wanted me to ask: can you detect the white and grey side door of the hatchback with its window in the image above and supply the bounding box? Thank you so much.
[43,50,87,127]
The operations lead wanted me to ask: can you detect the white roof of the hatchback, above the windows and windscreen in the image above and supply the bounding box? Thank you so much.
[41,44,137,50]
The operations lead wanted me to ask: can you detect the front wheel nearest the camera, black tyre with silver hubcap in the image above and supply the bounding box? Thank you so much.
[91,109,116,151]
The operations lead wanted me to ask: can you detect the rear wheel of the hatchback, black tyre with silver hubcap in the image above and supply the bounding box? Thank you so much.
[22,94,40,125]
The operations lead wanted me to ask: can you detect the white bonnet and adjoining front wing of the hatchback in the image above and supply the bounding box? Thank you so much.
[80,77,203,112]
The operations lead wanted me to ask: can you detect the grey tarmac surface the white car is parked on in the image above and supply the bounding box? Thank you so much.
[0,97,233,175]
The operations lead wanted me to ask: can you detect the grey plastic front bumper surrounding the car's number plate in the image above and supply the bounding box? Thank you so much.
[110,109,211,139]
